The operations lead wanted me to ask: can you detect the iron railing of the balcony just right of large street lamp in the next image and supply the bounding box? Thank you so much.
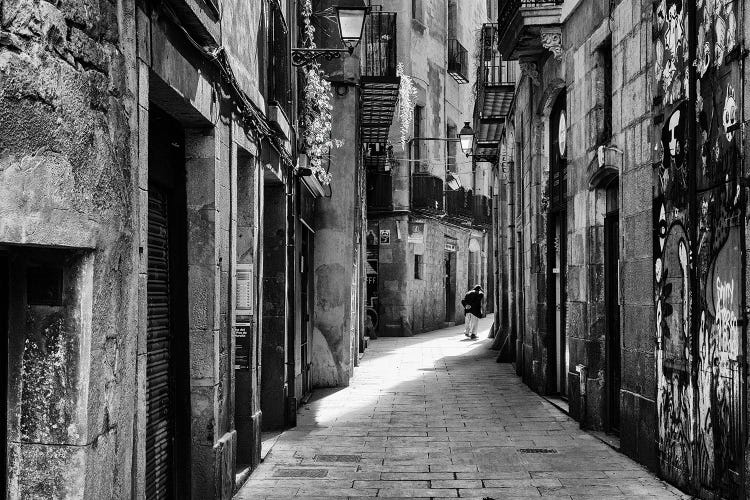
[362,12,397,78]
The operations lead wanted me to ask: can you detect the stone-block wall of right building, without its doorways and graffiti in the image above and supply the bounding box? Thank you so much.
[497,0,680,486]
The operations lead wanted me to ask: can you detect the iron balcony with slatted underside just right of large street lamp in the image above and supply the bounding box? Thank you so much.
[361,11,401,143]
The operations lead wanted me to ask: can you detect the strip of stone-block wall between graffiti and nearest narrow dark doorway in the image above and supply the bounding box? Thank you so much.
[612,0,657,468]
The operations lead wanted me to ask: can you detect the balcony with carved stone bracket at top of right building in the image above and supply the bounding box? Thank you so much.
[498,0,563,59]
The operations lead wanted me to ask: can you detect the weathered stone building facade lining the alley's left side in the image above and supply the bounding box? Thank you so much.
[0,0,372,499]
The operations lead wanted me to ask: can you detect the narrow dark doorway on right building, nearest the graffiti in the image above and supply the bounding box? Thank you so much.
[604,184,622,433]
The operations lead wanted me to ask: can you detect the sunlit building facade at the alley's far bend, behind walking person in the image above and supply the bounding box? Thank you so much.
[365,0,492,336]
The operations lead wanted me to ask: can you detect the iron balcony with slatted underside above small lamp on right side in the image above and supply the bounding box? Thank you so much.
[474,23,518,161]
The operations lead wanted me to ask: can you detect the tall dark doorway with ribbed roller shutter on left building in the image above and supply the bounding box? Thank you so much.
[145,106,190,499]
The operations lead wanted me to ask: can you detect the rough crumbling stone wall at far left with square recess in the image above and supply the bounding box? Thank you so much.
[0,0,138,498]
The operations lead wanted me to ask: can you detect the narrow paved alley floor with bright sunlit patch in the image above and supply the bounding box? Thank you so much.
[235,320,682,500]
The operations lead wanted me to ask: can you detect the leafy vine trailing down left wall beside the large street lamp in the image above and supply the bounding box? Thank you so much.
[301,0,344,184]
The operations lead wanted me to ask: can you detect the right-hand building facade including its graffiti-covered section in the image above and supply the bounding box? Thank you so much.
[488,0,747,498]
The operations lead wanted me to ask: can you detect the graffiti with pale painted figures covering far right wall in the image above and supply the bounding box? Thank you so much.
[653,0,744,494]
